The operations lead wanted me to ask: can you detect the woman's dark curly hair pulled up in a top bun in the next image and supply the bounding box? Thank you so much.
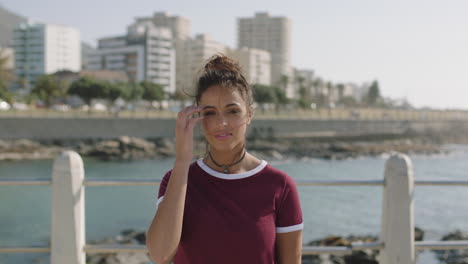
[195,54,253,111]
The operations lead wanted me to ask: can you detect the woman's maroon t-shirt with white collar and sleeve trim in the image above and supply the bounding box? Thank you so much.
[158,159,304,264]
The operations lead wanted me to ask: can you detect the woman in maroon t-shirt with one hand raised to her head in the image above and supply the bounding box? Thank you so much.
[146,55,303,264]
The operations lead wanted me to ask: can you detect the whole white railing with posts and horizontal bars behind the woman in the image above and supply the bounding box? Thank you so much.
[0,151,468,264]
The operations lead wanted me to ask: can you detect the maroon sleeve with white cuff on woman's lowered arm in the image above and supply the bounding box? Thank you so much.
[276,175,304,233]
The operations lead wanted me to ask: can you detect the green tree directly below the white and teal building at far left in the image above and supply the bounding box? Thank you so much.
[31,75,66,108]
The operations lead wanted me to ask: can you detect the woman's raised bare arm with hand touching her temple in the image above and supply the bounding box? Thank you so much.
[146,106,201,264]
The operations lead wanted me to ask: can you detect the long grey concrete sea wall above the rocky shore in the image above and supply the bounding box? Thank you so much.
[0,118,468,140]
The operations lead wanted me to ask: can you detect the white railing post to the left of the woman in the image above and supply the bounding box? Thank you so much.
[51,151,86,264]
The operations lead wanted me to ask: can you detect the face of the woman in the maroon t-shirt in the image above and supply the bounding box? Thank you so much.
[199,85,251,151]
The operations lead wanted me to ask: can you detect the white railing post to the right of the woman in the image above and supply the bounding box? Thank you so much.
[379,153,416,264]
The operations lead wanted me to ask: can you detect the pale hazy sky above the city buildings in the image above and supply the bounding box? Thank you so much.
[0,0,468,109]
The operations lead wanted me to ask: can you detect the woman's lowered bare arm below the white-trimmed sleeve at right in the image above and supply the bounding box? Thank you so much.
[276,230,302,264]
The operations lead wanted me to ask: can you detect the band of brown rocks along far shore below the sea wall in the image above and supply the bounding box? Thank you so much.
[0,133,458,161]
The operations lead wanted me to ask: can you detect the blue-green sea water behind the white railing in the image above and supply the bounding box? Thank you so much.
[0,145,468,264]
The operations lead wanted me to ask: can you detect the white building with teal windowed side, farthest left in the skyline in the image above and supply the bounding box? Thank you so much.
[14,22,81,88]
